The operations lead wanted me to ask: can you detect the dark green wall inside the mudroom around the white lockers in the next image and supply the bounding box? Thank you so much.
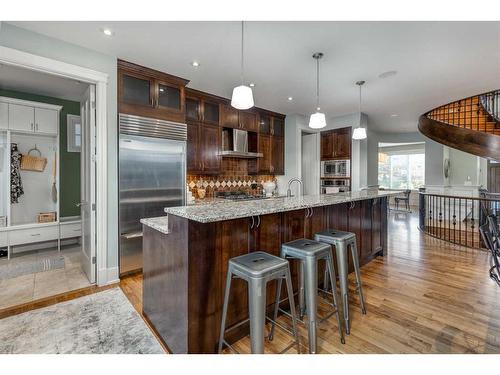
[0,89,80,217]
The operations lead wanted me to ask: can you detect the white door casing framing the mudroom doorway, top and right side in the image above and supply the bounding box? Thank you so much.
[0,46,113,285]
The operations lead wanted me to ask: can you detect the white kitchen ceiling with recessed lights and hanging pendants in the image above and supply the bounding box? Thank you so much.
[8,22,500,132]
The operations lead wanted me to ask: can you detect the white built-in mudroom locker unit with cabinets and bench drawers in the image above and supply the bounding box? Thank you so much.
[0,96,65,257]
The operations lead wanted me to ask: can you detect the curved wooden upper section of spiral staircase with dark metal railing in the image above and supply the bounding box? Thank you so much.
[418,90,500,161]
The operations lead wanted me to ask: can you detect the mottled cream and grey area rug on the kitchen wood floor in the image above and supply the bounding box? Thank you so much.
[0,288,164,354]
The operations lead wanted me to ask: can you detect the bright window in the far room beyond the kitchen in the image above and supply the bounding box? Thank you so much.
[378,143,425,190]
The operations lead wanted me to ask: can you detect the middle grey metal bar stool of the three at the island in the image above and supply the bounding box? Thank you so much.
[269,239,345,353]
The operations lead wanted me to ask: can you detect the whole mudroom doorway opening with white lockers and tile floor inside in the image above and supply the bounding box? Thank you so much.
[0,65,96,310]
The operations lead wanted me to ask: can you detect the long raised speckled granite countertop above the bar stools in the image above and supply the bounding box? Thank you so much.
[165,190,401,223]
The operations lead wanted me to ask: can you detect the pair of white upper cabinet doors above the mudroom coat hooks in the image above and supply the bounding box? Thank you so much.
[8,103,59,135]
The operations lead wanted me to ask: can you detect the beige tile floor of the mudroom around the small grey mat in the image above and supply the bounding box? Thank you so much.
[0,245,90,309]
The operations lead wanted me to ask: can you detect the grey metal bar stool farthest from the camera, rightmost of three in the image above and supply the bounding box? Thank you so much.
[314,229,366,334]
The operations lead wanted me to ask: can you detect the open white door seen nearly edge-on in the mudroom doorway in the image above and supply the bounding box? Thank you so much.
[80,85,96,283]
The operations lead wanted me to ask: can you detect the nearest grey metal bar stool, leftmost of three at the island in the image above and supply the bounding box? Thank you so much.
[219,251,299,354]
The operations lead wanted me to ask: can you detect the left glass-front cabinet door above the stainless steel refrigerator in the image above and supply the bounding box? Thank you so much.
[120,73,153,107]
